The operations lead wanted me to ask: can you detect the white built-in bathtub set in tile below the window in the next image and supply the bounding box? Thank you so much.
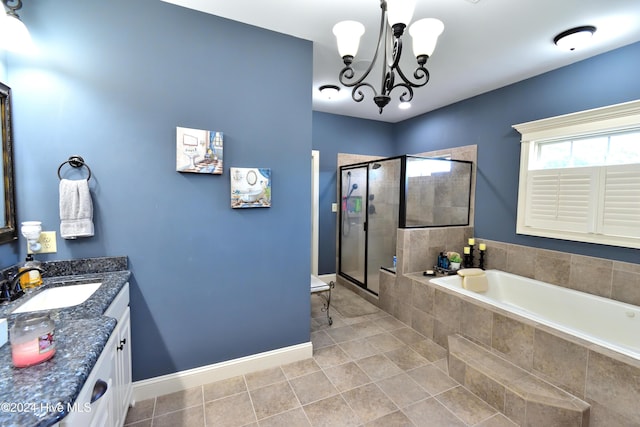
[430,270,640,361]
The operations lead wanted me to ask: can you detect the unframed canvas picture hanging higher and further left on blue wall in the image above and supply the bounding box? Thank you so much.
[176,127,224,175]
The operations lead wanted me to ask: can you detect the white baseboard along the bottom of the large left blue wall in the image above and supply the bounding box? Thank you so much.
[132,342,313,405]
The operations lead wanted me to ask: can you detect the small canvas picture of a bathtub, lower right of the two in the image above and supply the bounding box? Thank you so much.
[230,168,271,209]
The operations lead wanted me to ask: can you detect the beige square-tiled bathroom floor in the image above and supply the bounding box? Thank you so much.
[125,286,515,427]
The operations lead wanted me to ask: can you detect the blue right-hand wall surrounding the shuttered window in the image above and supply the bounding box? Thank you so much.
[395,43,640,263]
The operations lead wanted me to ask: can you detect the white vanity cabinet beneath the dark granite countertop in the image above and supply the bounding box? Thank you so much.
[59,283,132,427]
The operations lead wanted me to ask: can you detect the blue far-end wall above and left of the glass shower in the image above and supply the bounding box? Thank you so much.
[313,111,395,274]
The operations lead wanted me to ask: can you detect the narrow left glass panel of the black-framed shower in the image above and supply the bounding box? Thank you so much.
[339,166,367,286]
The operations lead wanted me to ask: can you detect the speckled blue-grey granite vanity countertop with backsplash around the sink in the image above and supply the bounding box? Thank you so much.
[0,257,130,427]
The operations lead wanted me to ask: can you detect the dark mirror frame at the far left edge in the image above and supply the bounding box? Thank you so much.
[0,83,18,244]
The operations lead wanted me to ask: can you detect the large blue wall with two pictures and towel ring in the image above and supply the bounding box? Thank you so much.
[2,0,312,380]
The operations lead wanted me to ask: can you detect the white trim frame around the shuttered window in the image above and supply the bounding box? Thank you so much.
[512,100,640,248]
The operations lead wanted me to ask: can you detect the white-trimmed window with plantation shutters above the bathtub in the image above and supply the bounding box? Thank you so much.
[514,101,640,248]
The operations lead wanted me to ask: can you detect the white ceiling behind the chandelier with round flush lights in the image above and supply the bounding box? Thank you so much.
[163,0,640,122]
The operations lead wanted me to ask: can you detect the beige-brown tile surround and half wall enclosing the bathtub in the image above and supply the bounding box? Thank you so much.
[352,231,640,427]
